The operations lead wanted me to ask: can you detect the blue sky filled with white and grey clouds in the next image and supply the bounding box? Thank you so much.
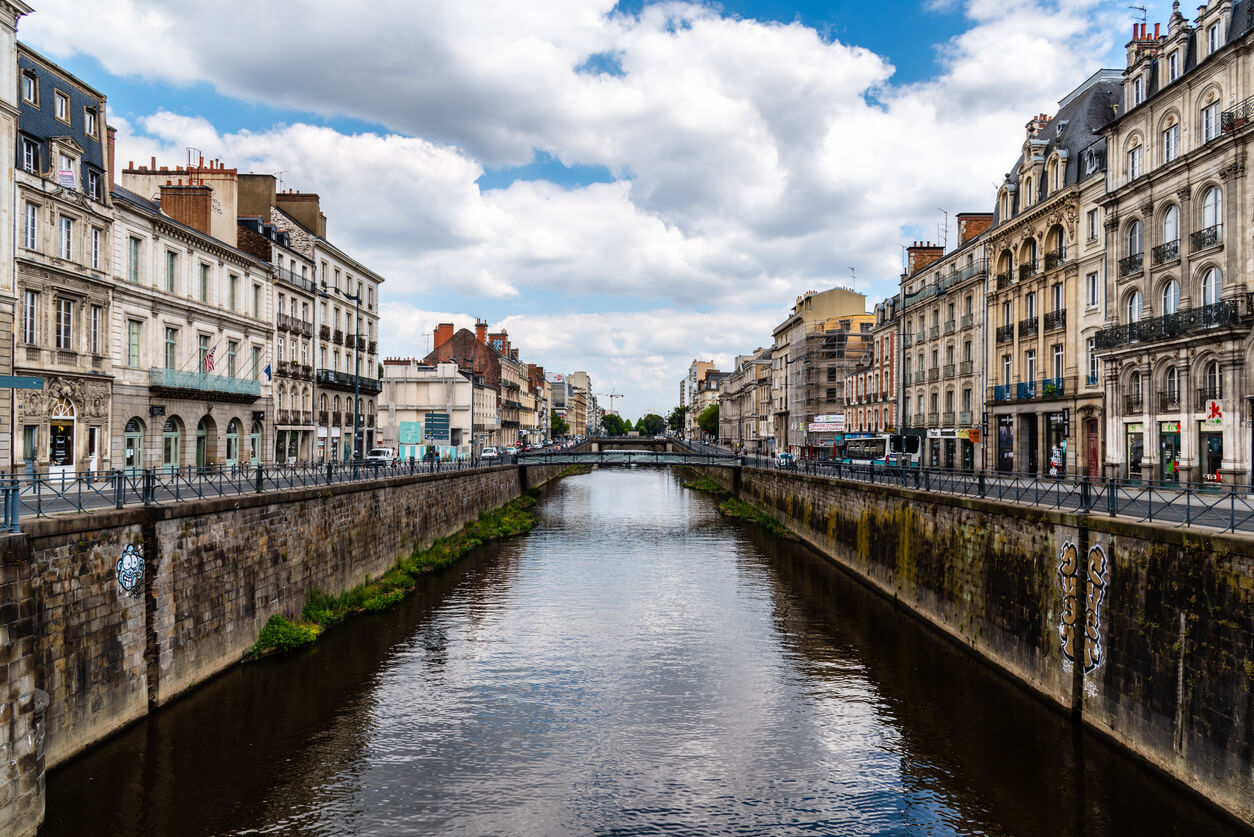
[19,0,1170,418]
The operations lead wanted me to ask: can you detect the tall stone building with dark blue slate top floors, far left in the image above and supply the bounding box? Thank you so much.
[13,45,114,473]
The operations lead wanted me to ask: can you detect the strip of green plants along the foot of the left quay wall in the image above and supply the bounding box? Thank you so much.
[245,491,539,660]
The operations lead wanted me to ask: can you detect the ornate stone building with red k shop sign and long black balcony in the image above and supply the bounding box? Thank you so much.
[1096,0,1254,483]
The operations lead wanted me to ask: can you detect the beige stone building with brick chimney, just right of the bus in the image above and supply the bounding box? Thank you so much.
[900,212,993,471]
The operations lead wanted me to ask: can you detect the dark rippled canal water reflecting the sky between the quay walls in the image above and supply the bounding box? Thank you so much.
[40,468,1245,837]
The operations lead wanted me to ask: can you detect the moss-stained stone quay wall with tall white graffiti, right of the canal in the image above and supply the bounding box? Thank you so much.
[696,467,1254,824]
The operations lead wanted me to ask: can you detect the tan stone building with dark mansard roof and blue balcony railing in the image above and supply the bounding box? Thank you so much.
[984,72,1120,474]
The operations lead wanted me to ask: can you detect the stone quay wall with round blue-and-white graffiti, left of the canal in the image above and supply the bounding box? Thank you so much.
[0,466,562,836]
